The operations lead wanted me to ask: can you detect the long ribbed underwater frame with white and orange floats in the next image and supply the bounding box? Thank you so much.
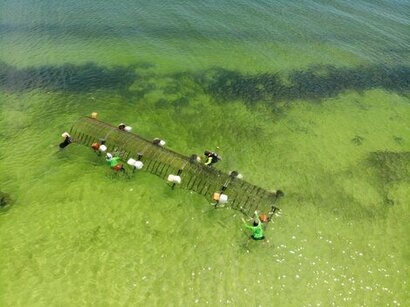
[70,117,283,219]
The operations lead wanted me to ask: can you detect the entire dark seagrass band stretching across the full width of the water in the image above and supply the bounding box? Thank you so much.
[0,62,410,105]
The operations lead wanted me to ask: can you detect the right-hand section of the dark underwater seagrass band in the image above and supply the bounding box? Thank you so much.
[203,65,410,104]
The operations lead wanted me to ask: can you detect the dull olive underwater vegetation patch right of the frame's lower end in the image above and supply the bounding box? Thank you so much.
[296,151,410,221]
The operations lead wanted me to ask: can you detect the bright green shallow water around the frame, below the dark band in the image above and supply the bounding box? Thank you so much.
[1,91,410,306]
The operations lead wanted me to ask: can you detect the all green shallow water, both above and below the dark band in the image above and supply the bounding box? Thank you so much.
[0,1,410,306]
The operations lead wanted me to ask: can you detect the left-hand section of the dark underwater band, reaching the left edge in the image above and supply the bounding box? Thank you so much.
[0,62,137,92]
